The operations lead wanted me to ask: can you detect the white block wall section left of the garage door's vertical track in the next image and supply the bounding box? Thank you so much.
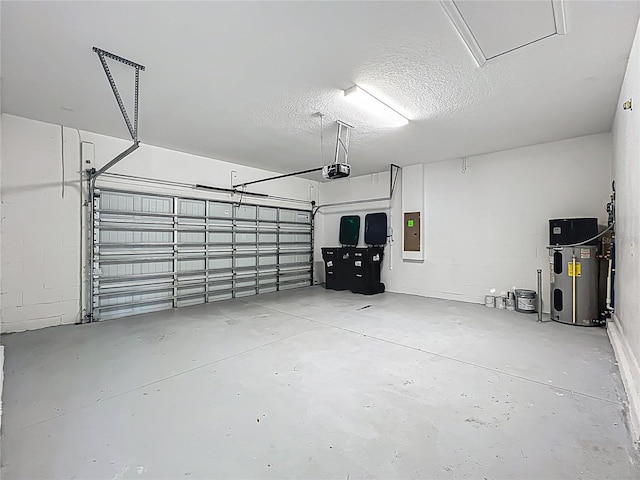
[2,115,81,332]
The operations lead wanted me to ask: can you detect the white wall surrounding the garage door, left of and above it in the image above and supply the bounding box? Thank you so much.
[0,114,317,332]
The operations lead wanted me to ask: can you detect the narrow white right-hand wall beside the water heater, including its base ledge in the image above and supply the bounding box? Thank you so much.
[608,16,640,441]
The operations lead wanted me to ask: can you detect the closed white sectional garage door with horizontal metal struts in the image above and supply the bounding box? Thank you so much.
[91,189,312,320]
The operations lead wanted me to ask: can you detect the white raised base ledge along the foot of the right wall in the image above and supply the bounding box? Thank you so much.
[607,315,640,444]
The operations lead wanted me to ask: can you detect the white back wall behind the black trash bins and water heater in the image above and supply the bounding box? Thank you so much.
[316,133,611,310]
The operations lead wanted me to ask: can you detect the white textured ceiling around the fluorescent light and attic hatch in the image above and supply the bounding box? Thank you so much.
[1,1,640,175]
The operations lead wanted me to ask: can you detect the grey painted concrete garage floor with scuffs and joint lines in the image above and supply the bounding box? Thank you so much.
[1,287,640,480]
